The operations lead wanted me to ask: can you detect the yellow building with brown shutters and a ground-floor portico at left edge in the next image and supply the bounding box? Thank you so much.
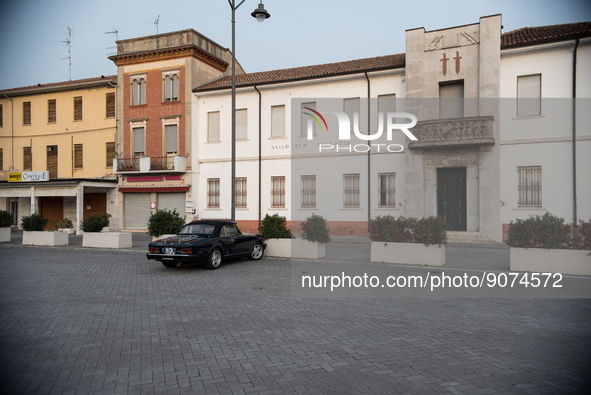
[0,76,118,232]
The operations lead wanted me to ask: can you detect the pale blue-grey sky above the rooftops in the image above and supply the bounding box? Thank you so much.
[0,0,591,90]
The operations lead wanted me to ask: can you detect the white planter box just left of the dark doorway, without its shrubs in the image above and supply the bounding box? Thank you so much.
[370,241,445,266]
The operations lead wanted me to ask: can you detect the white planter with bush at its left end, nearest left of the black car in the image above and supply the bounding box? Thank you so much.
[82,214,132,248]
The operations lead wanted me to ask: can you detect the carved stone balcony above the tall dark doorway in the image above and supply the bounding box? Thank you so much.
[408,116,495,149]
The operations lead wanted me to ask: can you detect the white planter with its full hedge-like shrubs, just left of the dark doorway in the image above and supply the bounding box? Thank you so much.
[370,215,447,266]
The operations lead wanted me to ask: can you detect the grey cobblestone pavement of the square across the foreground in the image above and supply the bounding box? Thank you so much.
[0,245,591,394]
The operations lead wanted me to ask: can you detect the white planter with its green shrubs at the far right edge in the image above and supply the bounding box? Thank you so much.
[507,213,591,276]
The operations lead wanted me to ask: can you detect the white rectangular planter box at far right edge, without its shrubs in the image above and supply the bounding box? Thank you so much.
[509,247,591,276]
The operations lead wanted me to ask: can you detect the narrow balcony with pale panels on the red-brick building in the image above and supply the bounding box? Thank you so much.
[113,155,187,174]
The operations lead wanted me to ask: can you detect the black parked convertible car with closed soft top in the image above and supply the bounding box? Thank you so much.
[146,221,267,269]
